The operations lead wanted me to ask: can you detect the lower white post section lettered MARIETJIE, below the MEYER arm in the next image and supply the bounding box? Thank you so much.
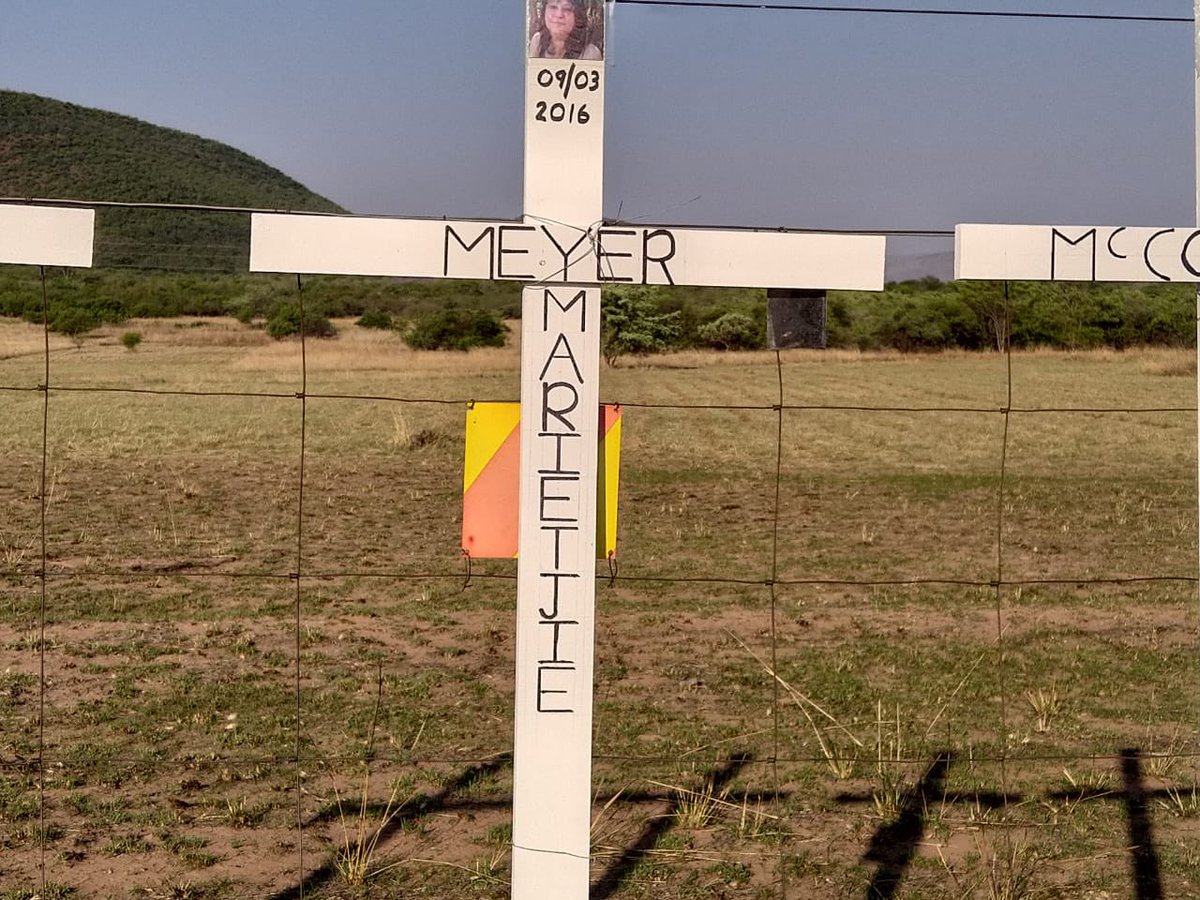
[512,286,600,900]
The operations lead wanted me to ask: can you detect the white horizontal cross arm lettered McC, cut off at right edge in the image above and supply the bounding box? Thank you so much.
[954,224,1200,282]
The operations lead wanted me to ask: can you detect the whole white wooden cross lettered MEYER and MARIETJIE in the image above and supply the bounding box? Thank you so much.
[250,0,884,900]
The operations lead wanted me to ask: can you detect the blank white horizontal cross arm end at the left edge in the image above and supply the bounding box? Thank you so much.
[0,205,96,269]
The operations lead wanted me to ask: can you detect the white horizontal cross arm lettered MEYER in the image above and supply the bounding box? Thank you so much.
[250,214,886,290]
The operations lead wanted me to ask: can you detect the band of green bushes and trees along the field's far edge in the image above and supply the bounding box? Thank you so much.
[0,266,1196,360]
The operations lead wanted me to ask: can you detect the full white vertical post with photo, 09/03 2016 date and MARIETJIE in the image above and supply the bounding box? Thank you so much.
[512,0,605,900]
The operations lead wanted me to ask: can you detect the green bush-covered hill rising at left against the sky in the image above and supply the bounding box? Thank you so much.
[0,90,344,271]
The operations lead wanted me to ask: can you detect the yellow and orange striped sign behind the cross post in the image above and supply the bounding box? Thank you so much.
[462,403,620,559]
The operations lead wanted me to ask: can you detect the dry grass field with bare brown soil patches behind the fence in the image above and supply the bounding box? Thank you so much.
[0,319,1200,900]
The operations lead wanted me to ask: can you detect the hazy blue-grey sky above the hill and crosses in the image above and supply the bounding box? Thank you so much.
[0,0,1195,255]
